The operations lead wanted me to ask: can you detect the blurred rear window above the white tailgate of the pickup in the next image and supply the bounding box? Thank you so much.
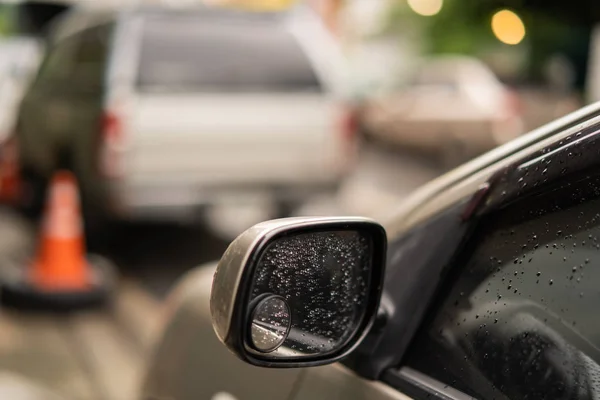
[138,17,320,92]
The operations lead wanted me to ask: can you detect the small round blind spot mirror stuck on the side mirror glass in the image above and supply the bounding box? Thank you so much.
[250,295,291,353]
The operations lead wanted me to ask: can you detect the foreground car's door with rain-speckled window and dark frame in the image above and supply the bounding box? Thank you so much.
[383,117,600,400]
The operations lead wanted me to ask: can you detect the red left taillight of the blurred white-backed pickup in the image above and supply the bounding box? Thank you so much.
[99,111,124,178]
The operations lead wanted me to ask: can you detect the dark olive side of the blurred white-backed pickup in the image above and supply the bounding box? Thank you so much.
[17,23,113,217]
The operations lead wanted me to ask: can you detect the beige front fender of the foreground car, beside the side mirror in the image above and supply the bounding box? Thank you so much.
[140,263,302,400]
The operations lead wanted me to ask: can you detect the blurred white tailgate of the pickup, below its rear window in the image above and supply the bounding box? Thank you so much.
[124,94,342,185]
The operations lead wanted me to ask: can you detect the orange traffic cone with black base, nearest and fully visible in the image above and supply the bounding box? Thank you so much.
[2,171,112,310]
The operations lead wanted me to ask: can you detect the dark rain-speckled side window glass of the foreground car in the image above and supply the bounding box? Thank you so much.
[404,178,600,400]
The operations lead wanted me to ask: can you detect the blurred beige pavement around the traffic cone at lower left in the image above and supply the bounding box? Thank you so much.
[0,208,161,400]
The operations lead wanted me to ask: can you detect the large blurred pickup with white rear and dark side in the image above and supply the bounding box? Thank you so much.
[16,7,354,228]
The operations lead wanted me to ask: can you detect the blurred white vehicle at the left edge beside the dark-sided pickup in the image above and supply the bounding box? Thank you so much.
[0,36,42,141]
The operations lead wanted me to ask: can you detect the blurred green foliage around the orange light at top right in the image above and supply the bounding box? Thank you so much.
[384,0,590,84]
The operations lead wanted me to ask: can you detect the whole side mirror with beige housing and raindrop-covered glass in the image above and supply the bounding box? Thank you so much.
[210,217,387,367]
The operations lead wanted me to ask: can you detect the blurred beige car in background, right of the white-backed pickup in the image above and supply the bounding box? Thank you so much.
[360,56,524,166]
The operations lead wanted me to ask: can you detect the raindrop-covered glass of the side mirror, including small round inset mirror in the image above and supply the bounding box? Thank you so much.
[246,230,373,358]
